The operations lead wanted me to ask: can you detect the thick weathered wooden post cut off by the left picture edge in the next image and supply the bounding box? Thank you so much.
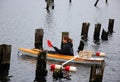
[0,44,11,82]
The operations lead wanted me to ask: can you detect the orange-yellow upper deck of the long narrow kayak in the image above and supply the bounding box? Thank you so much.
[18,48,104,63]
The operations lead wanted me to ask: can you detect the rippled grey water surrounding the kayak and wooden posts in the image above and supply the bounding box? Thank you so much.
[0,0,120,82]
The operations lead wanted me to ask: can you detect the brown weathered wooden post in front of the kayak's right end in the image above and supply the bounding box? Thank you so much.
[89,61,105,82]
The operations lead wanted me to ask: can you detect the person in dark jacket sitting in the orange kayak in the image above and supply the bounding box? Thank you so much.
[53,36,74,56]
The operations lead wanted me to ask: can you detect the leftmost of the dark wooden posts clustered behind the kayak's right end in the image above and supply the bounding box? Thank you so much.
[81,22,90,41]
